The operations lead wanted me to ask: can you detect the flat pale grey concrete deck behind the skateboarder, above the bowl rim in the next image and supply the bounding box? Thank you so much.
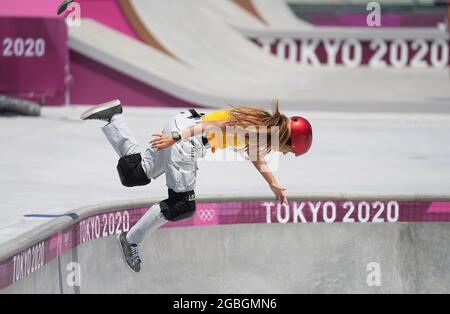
[0,106,450,243]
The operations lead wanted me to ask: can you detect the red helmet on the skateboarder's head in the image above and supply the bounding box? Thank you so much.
[290,116,312,157]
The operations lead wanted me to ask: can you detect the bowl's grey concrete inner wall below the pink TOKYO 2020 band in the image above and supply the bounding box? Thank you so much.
[5,223,450,293]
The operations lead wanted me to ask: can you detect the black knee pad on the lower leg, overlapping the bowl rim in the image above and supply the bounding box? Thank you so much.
[159,189,196,221]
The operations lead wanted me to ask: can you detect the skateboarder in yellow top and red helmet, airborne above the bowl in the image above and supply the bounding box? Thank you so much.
[81,100,312,272]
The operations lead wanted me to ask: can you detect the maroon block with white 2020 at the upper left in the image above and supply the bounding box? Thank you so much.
[0,16,69,104]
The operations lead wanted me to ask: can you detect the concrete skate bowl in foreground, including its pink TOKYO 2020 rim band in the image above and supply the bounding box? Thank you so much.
[0,195,450,293]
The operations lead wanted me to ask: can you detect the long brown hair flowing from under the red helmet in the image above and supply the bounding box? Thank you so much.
[227,100,290,155]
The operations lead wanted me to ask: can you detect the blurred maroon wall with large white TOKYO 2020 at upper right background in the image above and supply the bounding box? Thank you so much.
[246,27,450,69]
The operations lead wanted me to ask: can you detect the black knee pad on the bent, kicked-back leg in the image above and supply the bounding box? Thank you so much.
[117,154,151,187]
